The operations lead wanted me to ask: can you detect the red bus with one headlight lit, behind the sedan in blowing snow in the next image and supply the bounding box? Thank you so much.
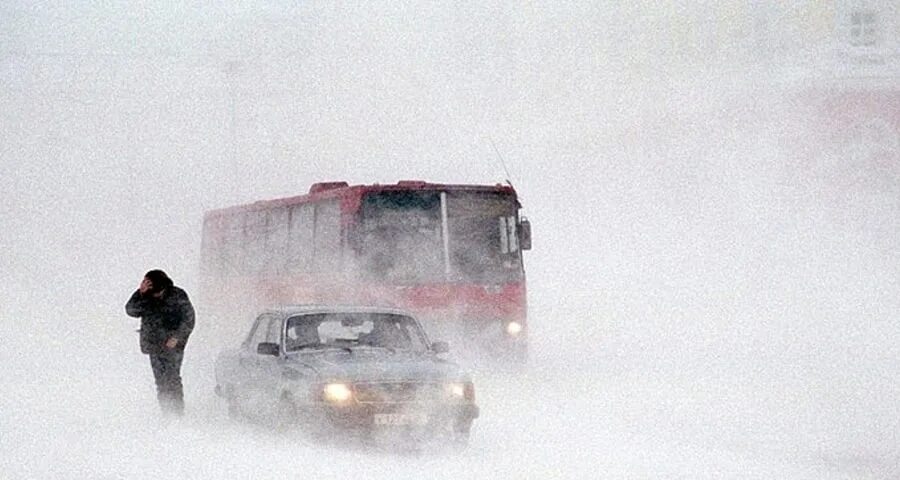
[201,181,531,362]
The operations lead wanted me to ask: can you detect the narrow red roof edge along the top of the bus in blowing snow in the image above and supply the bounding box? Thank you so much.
[204,180,516,217]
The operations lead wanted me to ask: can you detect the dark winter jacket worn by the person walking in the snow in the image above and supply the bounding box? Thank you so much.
[125,286,194,354]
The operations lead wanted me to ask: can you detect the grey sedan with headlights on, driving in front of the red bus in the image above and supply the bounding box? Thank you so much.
[215,306,479,444]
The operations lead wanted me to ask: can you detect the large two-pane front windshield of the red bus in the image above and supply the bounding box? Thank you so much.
[357,190,522,284]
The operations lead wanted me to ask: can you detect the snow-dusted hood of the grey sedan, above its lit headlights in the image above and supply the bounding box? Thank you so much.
[289,349,469,382]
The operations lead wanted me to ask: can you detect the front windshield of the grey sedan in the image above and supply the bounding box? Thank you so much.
[284,312,427,352]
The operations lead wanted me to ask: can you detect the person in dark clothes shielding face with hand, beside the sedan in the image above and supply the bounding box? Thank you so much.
[125,270,194,415]
